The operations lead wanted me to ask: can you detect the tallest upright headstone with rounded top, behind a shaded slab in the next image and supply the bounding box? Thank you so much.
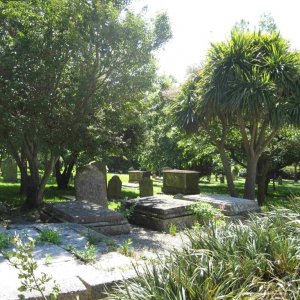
[75,165,107,207]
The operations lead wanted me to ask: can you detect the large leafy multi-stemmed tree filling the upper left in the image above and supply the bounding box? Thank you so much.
[0,0,170,206]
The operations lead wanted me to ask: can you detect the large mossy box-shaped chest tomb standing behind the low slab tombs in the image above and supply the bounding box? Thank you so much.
[162,170,199,194]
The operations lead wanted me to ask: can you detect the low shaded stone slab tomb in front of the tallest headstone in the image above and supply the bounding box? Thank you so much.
[43,200,130,235]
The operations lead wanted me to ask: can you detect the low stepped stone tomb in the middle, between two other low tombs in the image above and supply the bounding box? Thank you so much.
[126,195,195,232]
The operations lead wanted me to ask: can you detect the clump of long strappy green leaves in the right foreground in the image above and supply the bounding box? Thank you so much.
[109,210,300,300]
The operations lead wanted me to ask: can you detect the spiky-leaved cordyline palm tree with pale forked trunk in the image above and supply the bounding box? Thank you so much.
[175,31,300,199]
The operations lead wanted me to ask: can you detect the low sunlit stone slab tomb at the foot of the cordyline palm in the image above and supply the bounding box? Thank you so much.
[182,195,260,216]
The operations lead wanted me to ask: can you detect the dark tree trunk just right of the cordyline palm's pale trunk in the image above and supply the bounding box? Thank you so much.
[257,153,271,206]
